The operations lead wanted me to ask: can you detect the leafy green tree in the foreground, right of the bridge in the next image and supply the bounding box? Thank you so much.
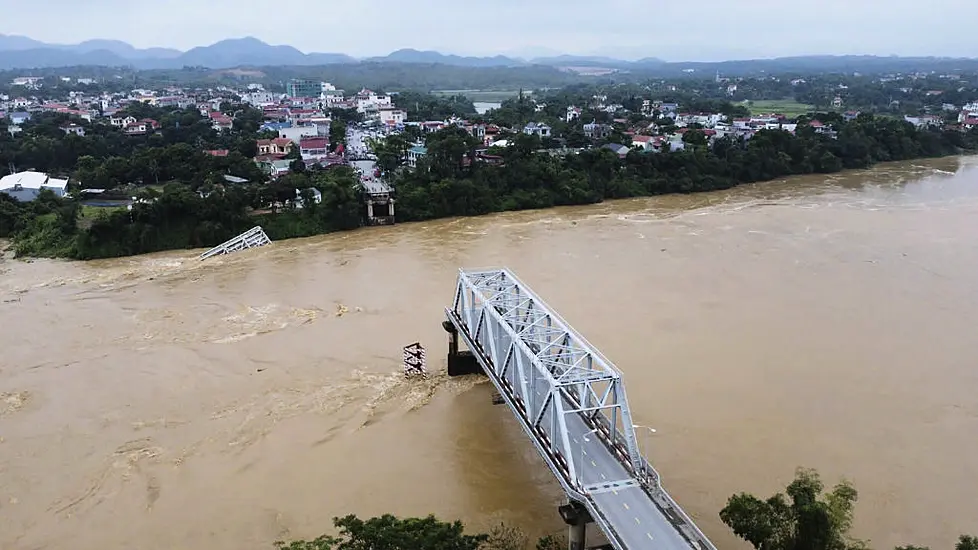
[720,468,978,550]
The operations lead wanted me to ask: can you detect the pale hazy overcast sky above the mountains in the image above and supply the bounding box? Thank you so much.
[0,0,978,61]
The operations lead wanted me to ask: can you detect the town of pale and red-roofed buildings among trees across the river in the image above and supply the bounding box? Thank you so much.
[0,67,978,256]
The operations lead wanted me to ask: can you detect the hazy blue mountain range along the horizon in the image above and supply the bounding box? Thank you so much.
[0,34,662,69]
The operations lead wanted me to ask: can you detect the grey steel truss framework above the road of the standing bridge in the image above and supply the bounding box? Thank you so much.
[452,269,648,494]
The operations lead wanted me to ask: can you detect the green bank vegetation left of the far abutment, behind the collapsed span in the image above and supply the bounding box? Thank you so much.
[0,167,362,260]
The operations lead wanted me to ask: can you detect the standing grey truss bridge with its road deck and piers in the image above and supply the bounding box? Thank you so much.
[445,269,716,550]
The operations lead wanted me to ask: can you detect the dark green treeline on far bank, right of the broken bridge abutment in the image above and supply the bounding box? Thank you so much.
[393,113,978,221]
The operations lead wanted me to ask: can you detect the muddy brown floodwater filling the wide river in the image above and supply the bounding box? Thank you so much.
[0,158,978,550]
